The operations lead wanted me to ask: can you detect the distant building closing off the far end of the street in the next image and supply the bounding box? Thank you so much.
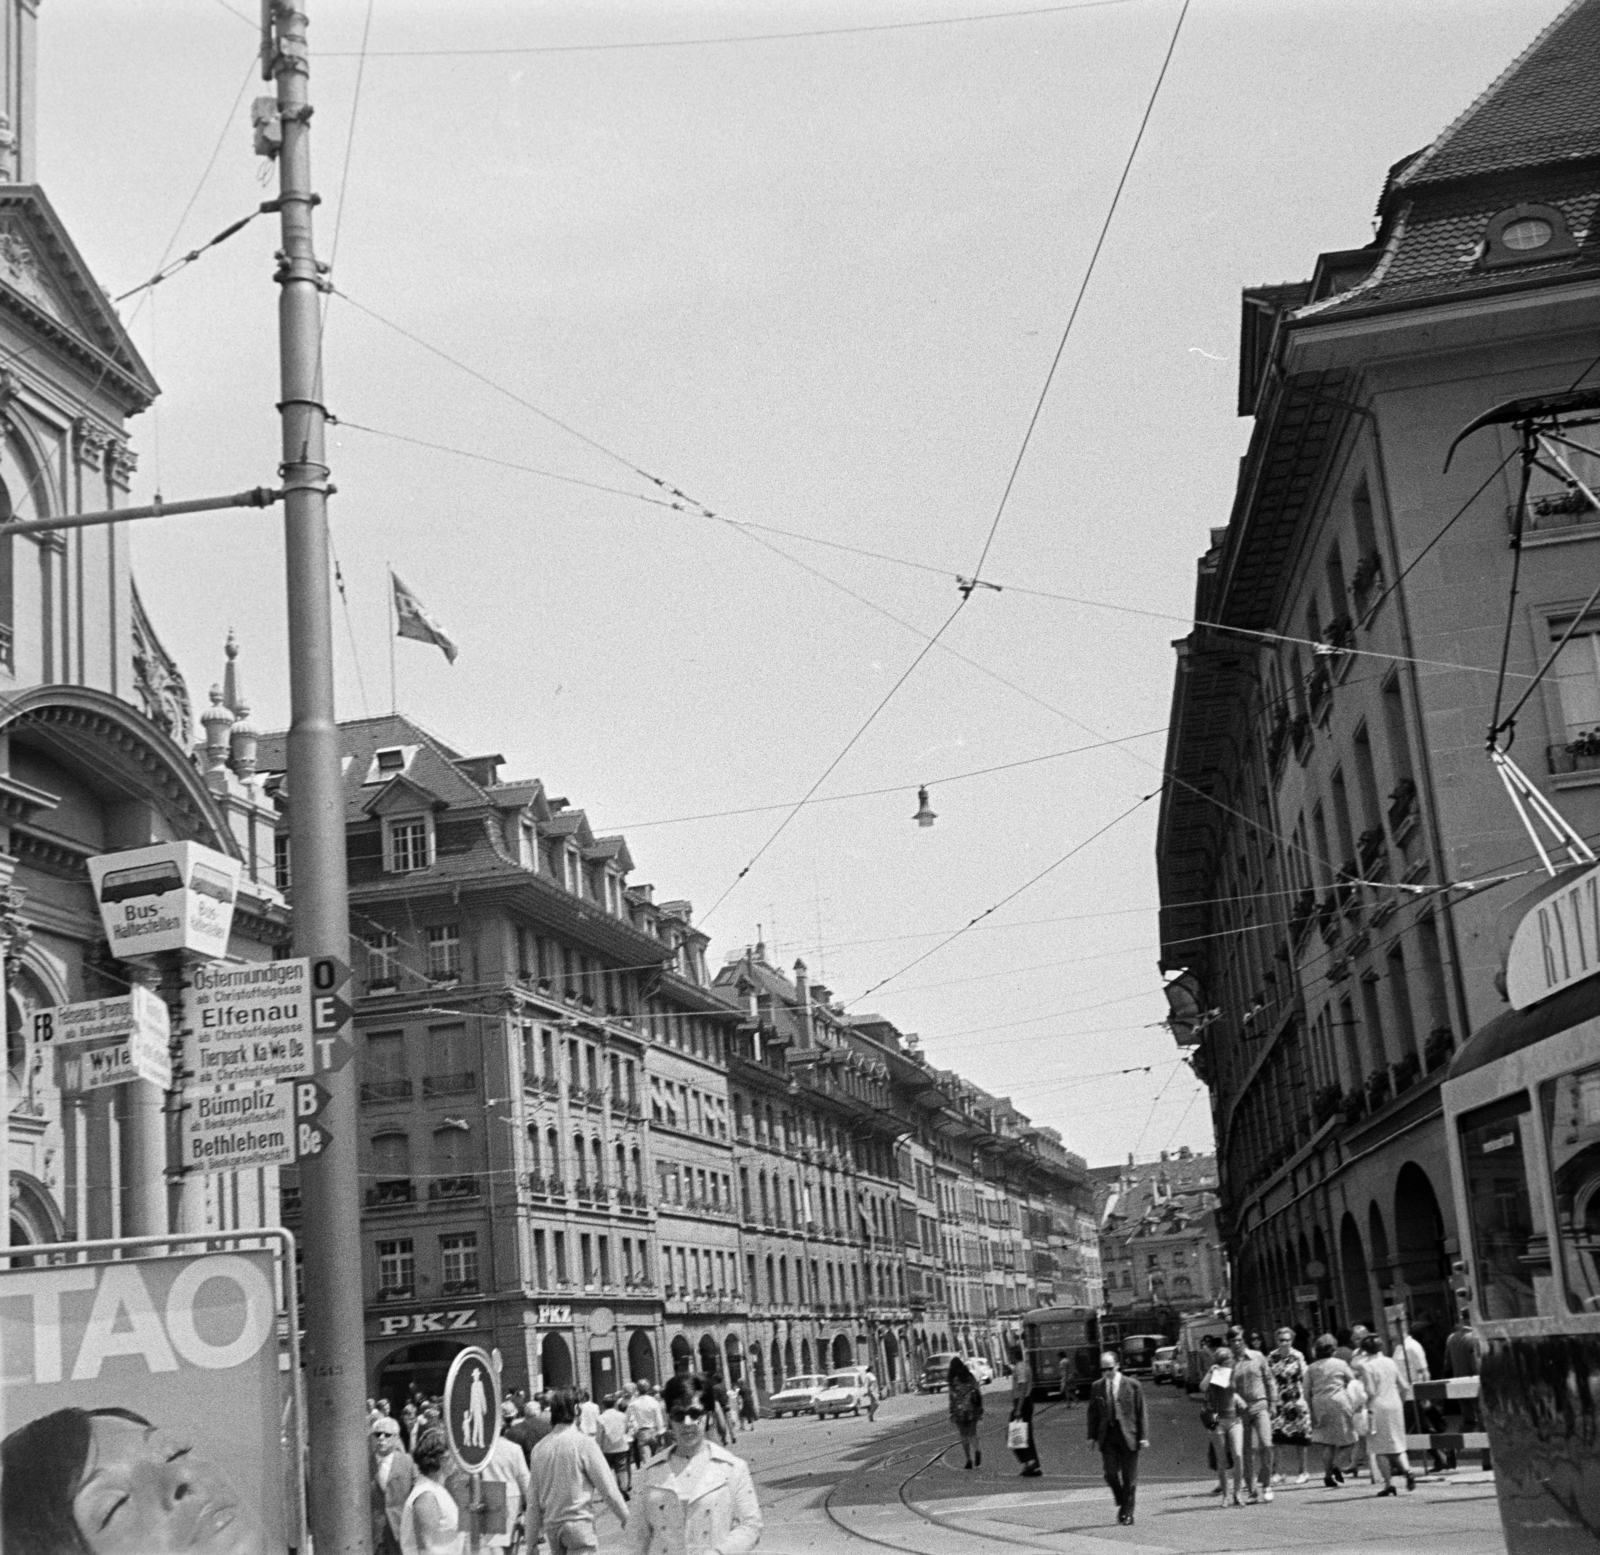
[1090,1145,1227,1312]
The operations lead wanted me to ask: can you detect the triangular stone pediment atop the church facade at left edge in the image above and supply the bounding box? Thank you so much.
[0,184,160,414]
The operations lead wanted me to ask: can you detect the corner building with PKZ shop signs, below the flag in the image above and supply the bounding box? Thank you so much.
[261,717,681,1397]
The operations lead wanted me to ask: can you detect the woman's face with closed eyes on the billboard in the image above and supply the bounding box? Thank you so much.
[72,1416,261,1555]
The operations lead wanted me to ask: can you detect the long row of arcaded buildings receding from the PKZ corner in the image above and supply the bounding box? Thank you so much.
[259,715,1085,1398]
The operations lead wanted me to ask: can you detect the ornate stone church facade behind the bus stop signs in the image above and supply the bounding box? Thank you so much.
[0,0,286,1248]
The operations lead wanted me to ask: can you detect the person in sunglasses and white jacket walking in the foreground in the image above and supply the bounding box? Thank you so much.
[622,1374,762,1555]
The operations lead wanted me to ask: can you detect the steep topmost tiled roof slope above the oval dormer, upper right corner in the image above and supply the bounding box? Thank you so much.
[1395,0,1600,189]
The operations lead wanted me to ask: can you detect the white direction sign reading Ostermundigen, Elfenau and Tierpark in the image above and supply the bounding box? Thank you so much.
[184,957,314,1085]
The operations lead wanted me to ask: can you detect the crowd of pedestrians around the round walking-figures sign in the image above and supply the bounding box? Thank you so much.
[368,1374,762,1555]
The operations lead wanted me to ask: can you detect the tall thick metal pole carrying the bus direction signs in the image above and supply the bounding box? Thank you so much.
[266,0,371,1555]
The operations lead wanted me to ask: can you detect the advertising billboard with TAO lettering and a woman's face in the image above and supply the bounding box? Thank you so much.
[0,1249,288,1555]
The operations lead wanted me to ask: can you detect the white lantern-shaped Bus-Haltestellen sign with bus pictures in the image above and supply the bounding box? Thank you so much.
[88,841,240,960]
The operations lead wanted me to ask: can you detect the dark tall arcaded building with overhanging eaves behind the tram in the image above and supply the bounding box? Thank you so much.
[1158,0,1600,1363]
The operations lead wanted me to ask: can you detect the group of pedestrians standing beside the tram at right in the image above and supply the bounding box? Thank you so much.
[1200,1317,1483,1507]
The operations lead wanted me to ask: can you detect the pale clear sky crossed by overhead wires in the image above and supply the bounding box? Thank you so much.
[38,0,1560,1165]
